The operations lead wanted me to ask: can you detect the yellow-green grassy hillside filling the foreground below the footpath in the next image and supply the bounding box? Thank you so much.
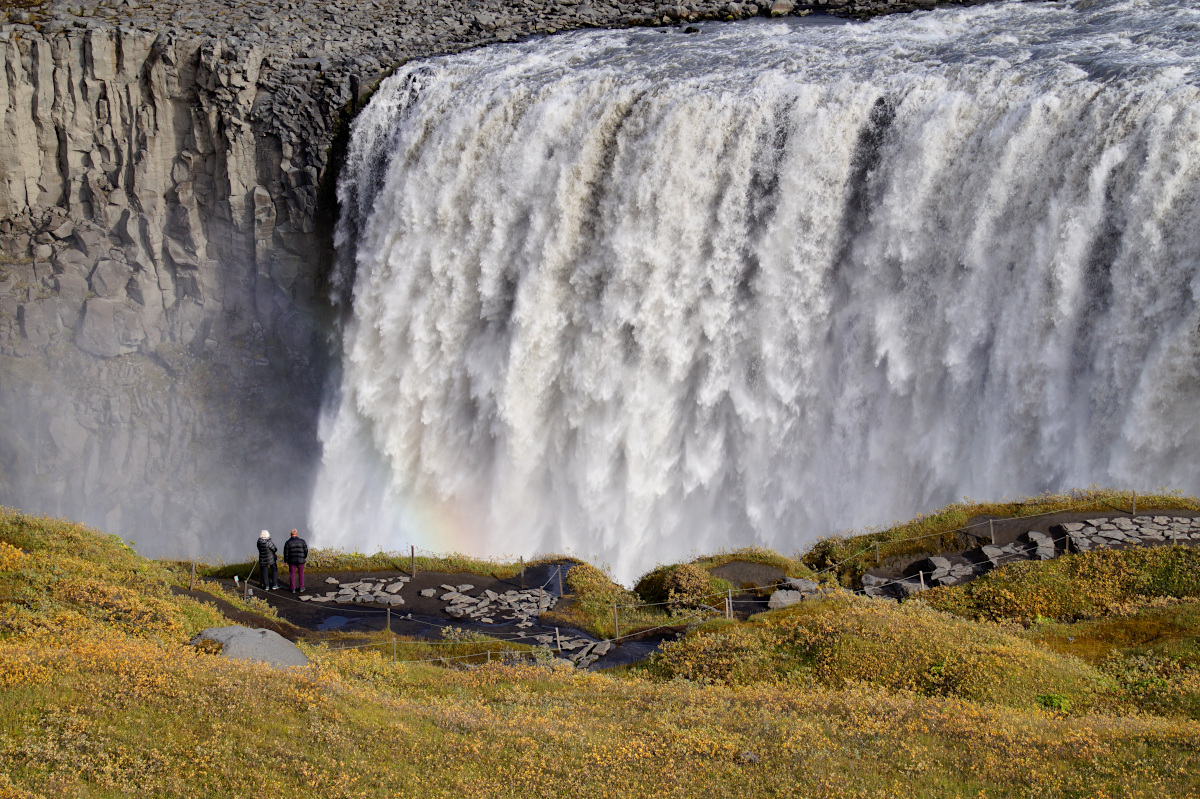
[0,512,1200,799]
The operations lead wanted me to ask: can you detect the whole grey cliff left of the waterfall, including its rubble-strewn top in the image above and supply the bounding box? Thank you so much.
[0,0,1003,558]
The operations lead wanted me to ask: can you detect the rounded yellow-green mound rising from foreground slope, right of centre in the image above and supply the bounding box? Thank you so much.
[650,594,1106,708]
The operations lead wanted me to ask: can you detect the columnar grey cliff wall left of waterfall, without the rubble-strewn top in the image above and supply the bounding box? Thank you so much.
[0,26,328,557]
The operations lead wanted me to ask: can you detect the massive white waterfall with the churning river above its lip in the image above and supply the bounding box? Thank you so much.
[311,1,1200,579]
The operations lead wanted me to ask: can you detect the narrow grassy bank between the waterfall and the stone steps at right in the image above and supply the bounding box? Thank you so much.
[800,487,1200,587]
